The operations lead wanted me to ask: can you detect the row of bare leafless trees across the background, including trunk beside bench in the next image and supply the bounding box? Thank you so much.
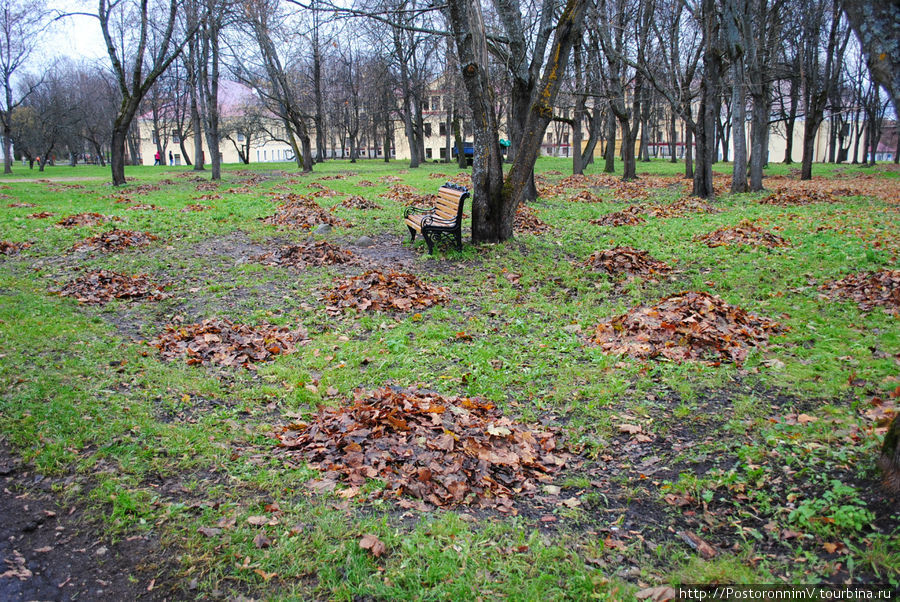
[0,0,900,241]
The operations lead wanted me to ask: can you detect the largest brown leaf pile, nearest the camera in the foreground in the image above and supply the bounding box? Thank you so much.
[275,387,569,510]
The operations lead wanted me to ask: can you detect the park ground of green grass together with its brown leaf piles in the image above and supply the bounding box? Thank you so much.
[0,159,900,600]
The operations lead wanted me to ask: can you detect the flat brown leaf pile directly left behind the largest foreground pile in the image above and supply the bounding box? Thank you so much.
[150,318,308,370]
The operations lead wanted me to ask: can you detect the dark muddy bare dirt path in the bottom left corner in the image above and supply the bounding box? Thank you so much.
[0,444,177,601]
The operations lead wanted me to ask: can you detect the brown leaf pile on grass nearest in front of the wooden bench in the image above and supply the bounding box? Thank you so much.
[325,270,447,316]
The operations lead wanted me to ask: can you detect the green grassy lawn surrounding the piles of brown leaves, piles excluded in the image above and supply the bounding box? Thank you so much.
[0,158,900,600]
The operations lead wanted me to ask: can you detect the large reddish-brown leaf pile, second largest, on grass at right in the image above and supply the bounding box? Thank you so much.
[593,291,781,363]
